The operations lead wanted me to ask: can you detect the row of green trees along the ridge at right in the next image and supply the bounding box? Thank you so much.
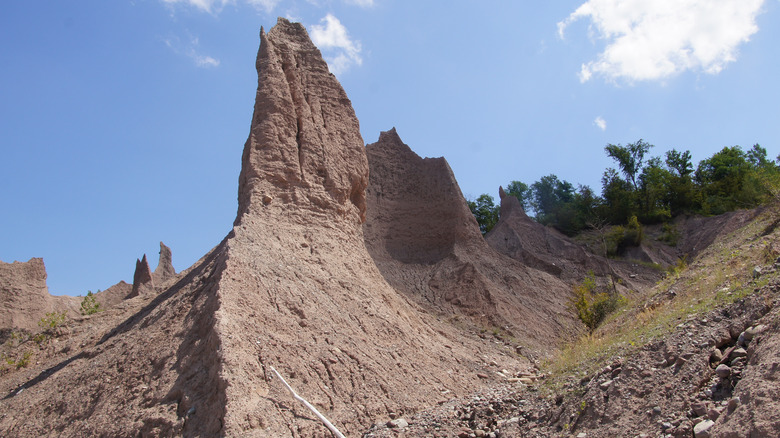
[467,139,780,236]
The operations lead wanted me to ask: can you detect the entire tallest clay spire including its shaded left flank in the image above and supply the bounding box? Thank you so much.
[0,19,527,437]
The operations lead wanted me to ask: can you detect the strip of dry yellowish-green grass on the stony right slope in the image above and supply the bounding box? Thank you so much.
[543,204,780,390]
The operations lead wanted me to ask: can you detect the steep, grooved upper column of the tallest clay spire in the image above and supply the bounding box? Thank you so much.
[235,18,368,225]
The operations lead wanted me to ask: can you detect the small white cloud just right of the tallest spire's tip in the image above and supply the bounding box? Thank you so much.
[310,14,363,75]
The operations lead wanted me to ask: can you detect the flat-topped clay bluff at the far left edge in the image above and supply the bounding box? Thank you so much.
[0,258,78,331]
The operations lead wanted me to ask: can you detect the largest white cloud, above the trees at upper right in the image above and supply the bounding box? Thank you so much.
[558,0,764,82]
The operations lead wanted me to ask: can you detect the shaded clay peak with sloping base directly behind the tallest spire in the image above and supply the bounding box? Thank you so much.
[364,129,575,350]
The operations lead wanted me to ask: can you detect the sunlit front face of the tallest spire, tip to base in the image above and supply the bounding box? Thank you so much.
[216,20,520,436]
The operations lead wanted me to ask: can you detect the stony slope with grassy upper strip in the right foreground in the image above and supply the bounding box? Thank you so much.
[365,209,780,438]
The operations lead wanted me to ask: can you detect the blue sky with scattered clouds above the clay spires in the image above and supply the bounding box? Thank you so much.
[0,0,780,295]
